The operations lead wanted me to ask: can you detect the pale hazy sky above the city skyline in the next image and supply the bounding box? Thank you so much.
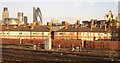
[0,0,118,24]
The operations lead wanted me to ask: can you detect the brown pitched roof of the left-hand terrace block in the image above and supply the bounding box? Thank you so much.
[0,25,49,32]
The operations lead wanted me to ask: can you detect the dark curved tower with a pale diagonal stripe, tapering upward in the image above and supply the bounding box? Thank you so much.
[33,7,42,22]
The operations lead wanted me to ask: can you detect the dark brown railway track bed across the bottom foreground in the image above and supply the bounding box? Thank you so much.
[2,48,117,62]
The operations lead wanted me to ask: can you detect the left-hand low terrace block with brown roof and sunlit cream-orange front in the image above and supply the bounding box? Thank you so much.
[0,25,51,39]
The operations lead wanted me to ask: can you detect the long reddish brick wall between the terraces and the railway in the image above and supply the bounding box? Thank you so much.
[0,38,120,50]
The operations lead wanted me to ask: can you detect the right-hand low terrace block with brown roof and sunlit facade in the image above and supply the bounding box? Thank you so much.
[54,26,111,41]
